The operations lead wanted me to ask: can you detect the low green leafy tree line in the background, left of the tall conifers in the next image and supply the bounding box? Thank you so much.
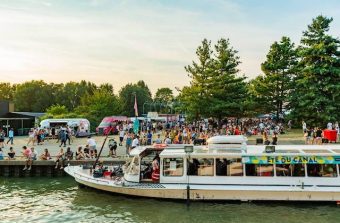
[0,80,174,131]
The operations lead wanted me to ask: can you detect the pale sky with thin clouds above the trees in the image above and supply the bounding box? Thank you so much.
[0,0,340,93]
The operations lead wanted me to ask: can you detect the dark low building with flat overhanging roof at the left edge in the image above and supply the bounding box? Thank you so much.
[0,101,45,135]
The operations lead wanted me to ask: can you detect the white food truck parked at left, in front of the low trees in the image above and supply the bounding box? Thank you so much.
[40,118,90,137]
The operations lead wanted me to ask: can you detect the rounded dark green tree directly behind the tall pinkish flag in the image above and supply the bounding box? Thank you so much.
[119,81,152,117]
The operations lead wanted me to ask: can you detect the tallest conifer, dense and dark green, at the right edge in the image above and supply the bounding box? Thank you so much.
[291,16,340,126]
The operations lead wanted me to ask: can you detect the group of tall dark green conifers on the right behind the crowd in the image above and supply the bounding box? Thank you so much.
[179,16,340,126]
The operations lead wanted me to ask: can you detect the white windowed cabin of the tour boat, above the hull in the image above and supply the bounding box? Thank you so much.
[124,136,340,185]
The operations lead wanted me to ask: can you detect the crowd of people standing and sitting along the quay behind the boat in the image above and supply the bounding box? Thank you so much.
[0,118,340,170]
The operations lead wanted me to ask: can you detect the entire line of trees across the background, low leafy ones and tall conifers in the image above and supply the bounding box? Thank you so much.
[0,16,340,126]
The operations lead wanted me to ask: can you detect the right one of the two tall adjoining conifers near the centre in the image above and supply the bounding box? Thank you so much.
[208,39,247,120]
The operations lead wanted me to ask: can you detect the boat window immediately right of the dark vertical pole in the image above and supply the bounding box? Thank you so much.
[188,158,214,176]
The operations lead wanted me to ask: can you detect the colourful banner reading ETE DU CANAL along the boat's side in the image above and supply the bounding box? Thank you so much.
[242,156,340,164]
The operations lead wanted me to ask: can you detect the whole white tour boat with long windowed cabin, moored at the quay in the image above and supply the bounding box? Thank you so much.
[65,136,340,202]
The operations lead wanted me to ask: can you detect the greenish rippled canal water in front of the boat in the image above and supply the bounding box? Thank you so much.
[0,177,340,223]
